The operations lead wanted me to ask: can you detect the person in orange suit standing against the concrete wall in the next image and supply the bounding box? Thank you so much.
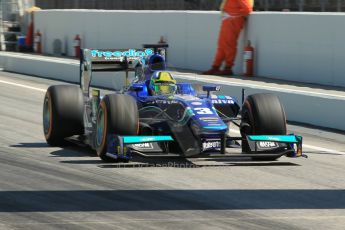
[203,0,254,75]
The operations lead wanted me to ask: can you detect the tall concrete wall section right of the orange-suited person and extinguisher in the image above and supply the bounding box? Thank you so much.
[248,12,345,86]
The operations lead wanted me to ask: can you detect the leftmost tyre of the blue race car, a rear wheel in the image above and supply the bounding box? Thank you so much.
[43,85,84,146]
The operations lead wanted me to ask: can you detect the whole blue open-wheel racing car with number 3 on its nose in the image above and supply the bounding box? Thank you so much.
[43,47,303,162]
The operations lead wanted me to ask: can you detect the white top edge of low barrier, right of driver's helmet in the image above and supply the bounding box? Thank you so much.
[174,74,345,100]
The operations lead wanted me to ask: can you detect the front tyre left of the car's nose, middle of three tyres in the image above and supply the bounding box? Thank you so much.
[95,94,139,162]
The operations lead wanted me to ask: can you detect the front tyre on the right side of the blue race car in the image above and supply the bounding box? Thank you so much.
[241,93,286,160]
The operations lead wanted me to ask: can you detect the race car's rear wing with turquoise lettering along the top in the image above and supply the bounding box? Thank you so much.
[80,48,154,96]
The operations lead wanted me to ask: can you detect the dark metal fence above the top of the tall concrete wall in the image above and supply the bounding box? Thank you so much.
[36,0,345,12]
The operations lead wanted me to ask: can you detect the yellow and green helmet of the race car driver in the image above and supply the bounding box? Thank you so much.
[150,71,177,95]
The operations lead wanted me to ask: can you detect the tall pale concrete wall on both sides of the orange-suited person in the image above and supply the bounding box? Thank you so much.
[35,10,345,86]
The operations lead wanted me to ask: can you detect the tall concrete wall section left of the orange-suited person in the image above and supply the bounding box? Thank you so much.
[35,10,245,72]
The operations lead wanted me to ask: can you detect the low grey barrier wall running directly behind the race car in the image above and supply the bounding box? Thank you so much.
[0,52,345,130]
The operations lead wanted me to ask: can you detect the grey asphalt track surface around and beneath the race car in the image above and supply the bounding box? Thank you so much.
[0,72,345,230]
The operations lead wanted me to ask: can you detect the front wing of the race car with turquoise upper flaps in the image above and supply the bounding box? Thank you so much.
[106,134,305,160]
